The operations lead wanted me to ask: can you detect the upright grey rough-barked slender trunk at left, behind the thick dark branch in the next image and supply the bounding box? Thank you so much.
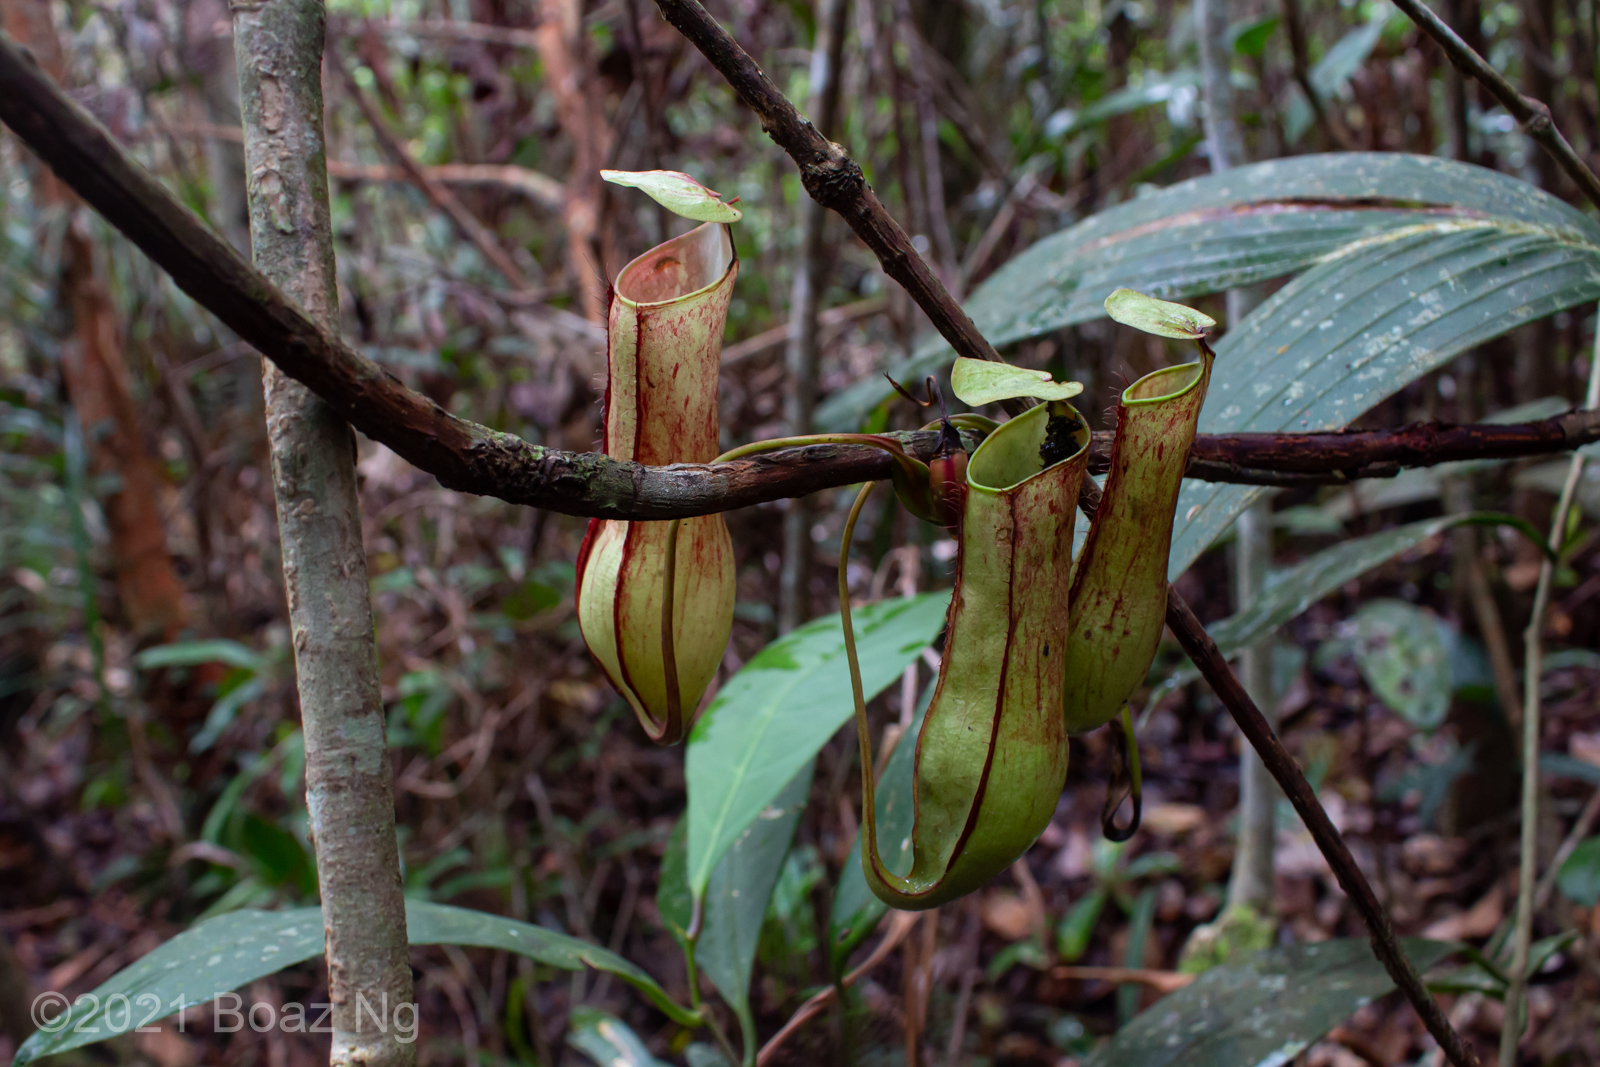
[234,0,416,1067]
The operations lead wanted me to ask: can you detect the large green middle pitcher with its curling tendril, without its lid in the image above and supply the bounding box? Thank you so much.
[840,402,1088,910]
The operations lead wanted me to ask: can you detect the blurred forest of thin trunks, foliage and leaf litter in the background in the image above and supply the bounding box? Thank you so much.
[9,0,1600,1067]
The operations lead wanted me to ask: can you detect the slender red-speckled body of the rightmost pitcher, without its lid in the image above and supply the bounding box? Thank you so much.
[1062,347,1211,733]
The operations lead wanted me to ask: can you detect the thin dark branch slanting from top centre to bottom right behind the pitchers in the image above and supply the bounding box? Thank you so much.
[656,0,1477,1067]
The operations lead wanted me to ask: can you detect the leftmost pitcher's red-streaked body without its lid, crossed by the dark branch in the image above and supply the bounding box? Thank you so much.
[578,222,739,744]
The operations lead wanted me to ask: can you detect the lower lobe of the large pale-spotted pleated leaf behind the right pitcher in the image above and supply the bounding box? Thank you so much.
[1168,207,1600,577]
